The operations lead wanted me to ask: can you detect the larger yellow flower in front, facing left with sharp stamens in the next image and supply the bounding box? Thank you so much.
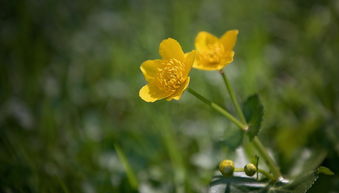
[139,38,195,102]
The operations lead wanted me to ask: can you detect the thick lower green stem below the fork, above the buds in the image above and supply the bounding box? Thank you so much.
[252,136,281,180]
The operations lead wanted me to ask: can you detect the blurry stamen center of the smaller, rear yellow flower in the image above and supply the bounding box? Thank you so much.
[200,43,224,65]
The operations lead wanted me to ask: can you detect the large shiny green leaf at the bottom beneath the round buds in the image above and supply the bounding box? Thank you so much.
[209,148,334,193]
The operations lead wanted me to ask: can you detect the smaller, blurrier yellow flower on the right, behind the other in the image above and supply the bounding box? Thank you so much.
[193,30,239,70]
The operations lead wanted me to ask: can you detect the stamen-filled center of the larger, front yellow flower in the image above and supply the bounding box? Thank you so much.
[157,58,186,93]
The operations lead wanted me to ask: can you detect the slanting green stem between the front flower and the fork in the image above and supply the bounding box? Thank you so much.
[187,88,247,131]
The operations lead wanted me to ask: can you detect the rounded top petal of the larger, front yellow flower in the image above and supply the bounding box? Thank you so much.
[159,38,184,61]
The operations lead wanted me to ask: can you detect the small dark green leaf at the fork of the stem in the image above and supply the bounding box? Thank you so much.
[243,94,264,139]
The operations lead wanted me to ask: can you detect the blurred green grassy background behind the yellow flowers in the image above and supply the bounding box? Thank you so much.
[0,0,339,193]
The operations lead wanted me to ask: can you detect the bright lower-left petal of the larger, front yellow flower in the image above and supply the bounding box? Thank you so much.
[139,84,169,102]
